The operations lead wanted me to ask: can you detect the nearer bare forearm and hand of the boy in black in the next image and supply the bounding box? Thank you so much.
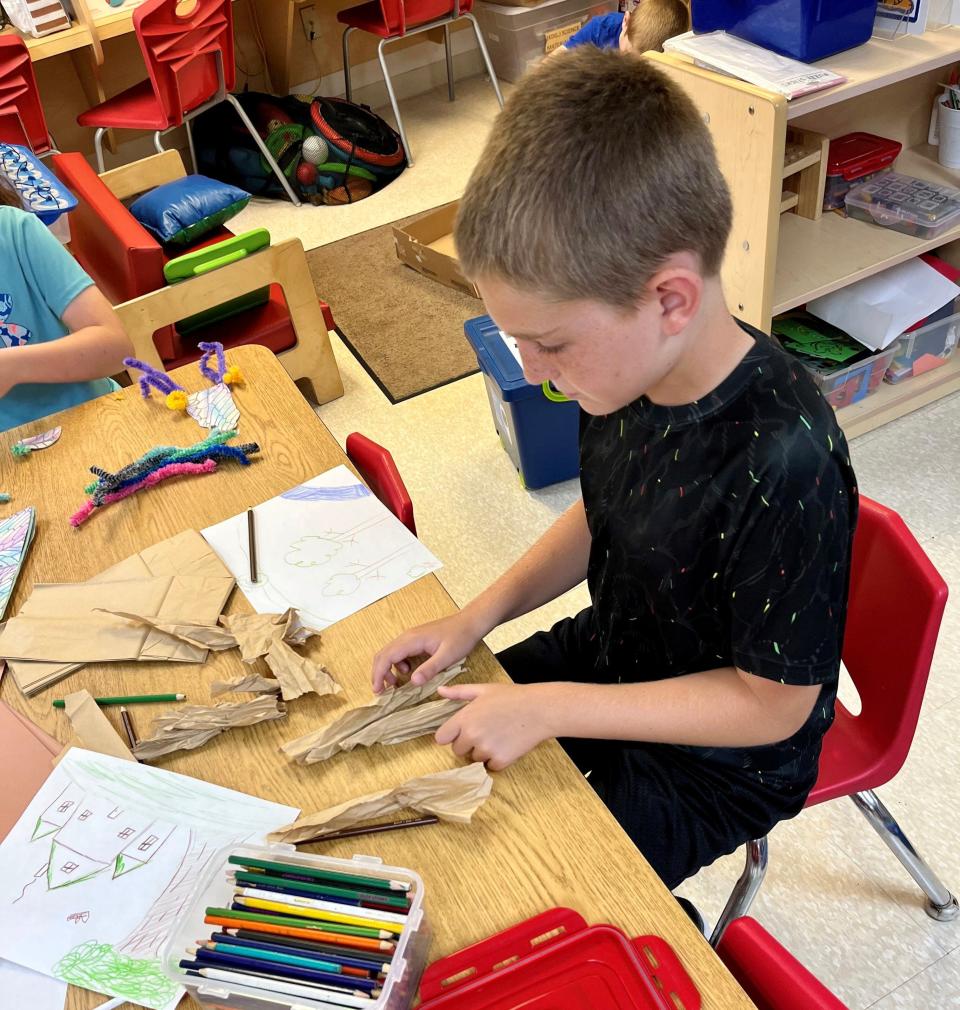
[437,667,821,771]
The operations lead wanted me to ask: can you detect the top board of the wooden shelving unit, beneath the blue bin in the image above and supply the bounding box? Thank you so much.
[787,26,960,119]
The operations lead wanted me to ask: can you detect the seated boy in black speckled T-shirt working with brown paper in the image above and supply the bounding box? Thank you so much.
[372,46,857,889]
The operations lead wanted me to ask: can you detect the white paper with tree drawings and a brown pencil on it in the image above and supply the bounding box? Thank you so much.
[201,467,441,630]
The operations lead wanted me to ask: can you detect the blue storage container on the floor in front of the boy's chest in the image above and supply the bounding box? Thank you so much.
[464,316,580,488]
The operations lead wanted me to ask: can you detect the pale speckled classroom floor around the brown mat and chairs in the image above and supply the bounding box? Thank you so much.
[257,79,960,1010]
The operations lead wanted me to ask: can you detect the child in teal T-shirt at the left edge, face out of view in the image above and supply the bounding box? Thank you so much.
[0,178,133,431]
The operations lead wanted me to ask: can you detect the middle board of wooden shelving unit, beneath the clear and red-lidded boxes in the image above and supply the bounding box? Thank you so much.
[773,144,960,314]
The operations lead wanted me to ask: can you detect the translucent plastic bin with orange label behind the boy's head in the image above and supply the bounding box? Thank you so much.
[473,0,616,81]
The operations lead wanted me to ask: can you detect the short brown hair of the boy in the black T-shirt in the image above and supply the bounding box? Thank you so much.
[455,45,732,308]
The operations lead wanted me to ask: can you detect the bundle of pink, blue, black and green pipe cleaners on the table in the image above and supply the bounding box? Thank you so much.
[70,430,260,526]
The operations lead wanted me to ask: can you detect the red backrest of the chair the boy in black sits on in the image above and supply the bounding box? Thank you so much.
[843,497,947,788]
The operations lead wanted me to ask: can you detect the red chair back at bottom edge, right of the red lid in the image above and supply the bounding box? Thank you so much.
[716,916,848,1010]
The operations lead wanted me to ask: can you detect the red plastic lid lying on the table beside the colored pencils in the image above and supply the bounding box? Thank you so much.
[419,908,700,1010]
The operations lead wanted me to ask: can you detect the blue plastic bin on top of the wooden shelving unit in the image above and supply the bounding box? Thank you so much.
[690,0,877,63]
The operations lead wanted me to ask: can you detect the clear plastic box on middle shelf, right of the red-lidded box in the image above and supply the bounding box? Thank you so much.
[846,172,960,240]
